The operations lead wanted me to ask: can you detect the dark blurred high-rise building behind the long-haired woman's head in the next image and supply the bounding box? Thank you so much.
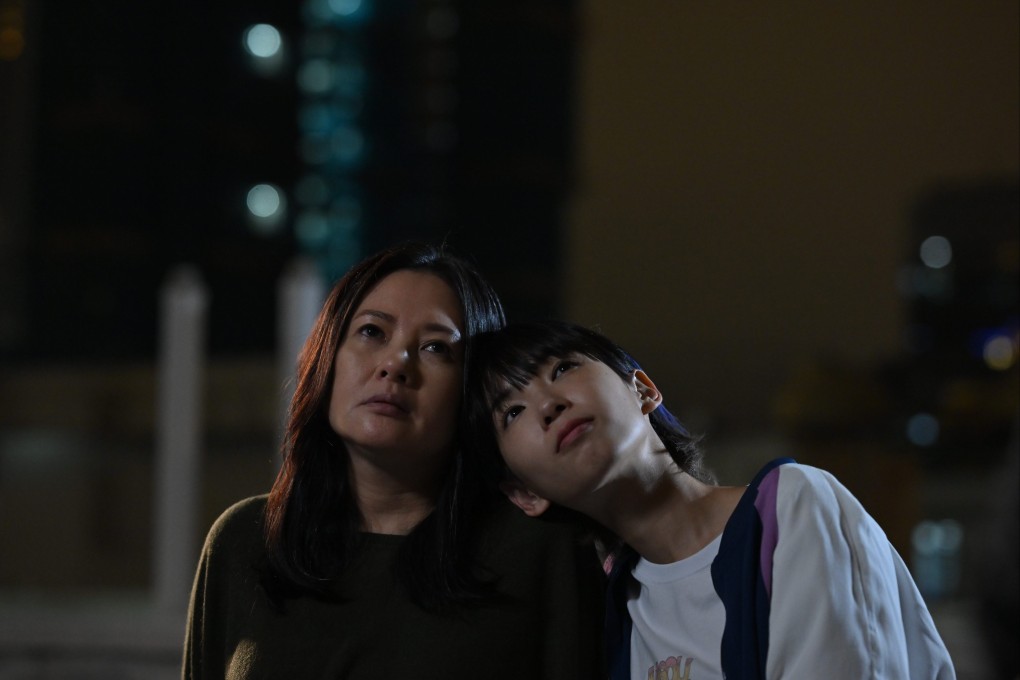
[7,1,576,359]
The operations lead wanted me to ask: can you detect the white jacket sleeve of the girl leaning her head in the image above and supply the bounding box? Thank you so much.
[766,465,956,680]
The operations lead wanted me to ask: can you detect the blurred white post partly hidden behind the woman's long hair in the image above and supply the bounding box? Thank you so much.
[275,258,325,466]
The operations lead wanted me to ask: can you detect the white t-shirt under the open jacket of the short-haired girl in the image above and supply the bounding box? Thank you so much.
[627,534,726,680]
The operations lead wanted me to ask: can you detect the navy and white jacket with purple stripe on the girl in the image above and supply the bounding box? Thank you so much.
[606,459,956,680]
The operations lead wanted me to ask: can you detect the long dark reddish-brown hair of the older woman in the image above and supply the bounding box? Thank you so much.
[265,243,506,611]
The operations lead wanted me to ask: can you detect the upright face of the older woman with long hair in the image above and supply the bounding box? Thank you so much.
[329,270,464,473]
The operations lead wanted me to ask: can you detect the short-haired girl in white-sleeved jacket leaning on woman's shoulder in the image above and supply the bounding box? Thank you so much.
[467,321,955,680]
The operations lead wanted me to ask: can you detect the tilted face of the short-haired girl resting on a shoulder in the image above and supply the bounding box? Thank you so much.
[493,355,661,511]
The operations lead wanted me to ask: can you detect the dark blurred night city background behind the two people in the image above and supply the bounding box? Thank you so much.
[0,0,1020,678]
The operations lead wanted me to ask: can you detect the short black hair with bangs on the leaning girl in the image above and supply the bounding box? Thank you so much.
[466,319,714,483]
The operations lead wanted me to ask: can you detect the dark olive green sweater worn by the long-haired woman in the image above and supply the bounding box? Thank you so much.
[183,495,603,680]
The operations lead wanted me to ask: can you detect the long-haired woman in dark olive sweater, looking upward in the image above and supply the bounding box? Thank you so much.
[184,245,602,679]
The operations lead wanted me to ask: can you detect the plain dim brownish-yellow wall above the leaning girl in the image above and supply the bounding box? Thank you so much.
[566,0,1020,426]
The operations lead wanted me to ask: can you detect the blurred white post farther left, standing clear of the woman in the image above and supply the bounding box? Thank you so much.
[153,265,208,613]
